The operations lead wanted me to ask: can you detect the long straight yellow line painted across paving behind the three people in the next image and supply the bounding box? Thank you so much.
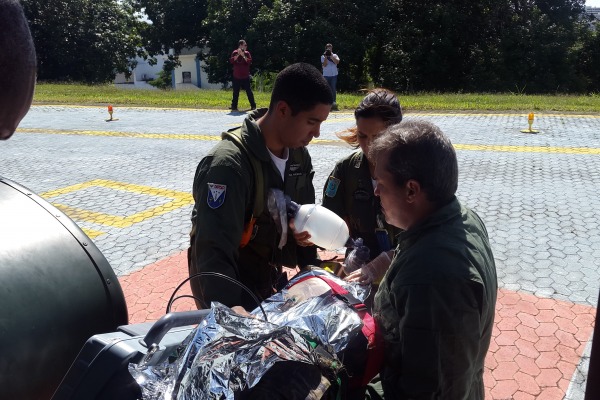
[18,128,600,155]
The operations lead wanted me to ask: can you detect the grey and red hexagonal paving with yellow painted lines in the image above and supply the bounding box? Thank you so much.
[0,106,600,400]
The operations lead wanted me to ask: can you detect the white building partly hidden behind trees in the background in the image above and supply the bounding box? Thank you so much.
[114,47,222,90]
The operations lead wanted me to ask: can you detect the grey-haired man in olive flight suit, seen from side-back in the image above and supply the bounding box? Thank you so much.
[369,121,498,400]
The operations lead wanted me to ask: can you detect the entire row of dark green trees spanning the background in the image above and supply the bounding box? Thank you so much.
[23,0,600,93]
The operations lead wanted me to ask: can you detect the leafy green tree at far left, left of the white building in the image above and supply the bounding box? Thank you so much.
[22,0,140,83]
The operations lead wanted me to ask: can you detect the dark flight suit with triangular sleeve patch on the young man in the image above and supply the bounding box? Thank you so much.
[188,109,317,309]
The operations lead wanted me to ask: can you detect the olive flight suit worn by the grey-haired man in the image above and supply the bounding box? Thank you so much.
[374,198,498,400]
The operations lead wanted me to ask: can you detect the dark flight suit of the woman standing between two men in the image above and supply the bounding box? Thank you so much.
[323,150,400,259]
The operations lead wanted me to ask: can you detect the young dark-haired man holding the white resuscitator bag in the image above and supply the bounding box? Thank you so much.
[188,63,333,310]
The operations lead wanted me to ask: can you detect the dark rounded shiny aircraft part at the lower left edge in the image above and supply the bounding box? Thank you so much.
[0,177,128,399]
